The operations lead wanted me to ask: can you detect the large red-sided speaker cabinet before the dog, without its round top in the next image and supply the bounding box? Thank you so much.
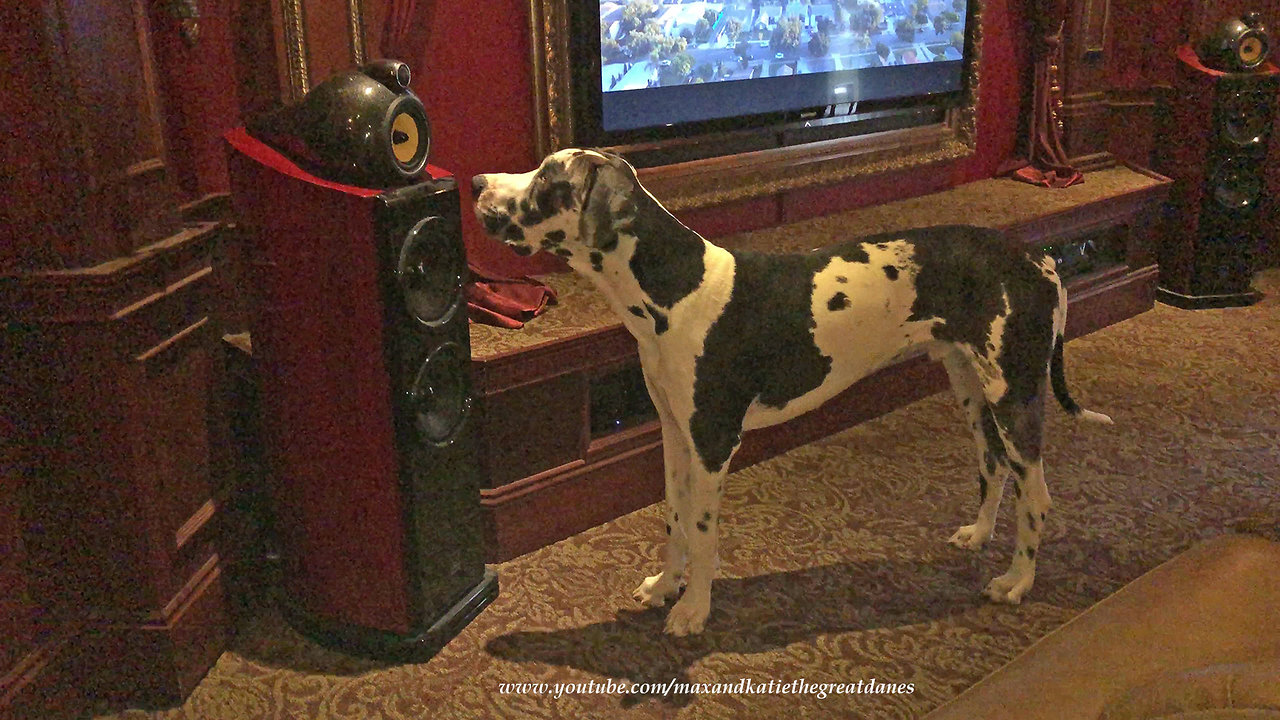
[227,129,498,659]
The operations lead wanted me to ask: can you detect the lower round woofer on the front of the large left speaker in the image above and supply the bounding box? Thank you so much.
[410,342,471,446]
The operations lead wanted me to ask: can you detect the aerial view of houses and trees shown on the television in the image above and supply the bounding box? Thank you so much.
[600,0,966,94]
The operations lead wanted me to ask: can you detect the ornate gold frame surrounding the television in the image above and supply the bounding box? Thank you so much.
[529,0,983,210]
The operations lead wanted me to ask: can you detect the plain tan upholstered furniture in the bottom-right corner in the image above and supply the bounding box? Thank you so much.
[925,536,1280,720]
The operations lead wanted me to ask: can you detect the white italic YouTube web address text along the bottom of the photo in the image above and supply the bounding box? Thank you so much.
[498,678,915,700]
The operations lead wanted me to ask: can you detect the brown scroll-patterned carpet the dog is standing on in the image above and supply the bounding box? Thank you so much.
[102,270,1280,720]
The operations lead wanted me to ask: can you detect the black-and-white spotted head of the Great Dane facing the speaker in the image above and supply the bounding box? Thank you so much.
[471,149,637,260]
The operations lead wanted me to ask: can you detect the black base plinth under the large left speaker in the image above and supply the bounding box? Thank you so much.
[280,568,498,662]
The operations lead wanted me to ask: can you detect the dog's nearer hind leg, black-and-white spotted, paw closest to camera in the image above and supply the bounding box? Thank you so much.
[983,384,1050,605]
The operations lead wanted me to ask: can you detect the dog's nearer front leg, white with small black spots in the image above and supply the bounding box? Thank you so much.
[667,460,728,637]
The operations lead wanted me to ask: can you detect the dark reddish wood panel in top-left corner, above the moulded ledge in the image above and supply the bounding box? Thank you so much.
[0,0,178,268]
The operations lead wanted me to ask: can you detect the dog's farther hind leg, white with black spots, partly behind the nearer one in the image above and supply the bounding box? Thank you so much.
[942,350,1009,550]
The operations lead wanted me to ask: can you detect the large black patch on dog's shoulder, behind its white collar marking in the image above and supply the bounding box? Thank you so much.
[690,245,839,471]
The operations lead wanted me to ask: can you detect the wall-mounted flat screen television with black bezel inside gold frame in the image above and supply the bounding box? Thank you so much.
[568,0,974,157]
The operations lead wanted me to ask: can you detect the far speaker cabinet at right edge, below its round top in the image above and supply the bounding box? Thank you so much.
[1156,45,1280,307]
